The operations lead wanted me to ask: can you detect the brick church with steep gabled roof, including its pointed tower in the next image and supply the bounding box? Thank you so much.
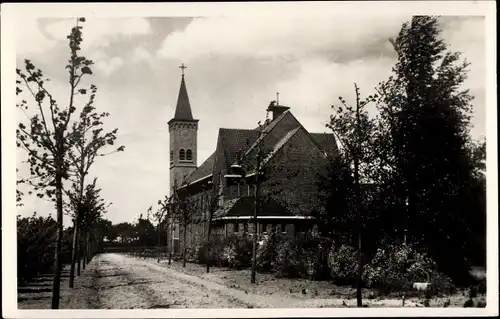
[168,65,338,255]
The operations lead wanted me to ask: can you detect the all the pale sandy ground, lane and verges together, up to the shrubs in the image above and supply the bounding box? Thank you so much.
[19,254,464,309]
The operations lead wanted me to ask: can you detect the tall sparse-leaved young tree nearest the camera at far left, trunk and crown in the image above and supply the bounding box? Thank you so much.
[16,18,93,309]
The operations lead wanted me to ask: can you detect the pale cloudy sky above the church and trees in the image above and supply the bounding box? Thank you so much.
[15,15,486,225]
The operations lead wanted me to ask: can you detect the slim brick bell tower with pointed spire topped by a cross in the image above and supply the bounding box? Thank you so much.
[168,64,198,194]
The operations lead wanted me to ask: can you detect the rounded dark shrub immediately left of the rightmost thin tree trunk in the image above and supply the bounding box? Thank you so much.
[328,245,358,284]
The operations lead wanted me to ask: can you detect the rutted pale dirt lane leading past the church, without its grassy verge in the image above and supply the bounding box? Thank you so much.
[68,254,262,309]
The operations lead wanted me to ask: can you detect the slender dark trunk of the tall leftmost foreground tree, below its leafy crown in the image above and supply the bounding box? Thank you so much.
[52,172,63,309]
